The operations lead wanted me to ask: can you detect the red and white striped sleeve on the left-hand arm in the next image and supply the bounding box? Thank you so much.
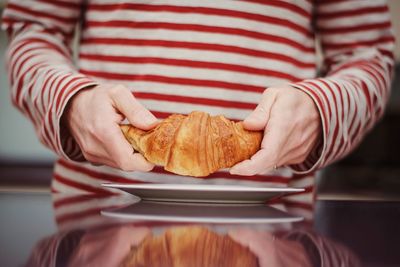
[2,0,95,161]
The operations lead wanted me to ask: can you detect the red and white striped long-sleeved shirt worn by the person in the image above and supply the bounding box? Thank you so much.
[3,0,394,208]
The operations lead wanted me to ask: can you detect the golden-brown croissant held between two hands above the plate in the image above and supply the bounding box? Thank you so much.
[121,111,262,176]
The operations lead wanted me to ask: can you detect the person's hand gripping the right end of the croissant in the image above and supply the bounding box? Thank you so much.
[230,87,321,175]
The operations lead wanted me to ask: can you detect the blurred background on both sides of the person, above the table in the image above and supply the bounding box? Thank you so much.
[0,0,400,198]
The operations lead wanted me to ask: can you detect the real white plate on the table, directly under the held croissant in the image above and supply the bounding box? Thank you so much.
[103,183,304,203]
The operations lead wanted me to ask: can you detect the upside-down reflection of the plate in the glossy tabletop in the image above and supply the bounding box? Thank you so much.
[101,201,303,223]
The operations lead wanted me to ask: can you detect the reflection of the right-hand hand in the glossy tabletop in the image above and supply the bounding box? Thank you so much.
[228,228,312,267]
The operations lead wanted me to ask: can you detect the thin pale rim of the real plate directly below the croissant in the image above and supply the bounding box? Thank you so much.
[101,183,305,193]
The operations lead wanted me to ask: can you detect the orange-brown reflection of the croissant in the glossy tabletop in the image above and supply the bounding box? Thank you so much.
[122,226,258,267]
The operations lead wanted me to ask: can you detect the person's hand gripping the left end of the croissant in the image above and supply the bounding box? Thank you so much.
[65,84,157,171]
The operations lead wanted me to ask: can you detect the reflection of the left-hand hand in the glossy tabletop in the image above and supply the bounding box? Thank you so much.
[68,225,151,267]
